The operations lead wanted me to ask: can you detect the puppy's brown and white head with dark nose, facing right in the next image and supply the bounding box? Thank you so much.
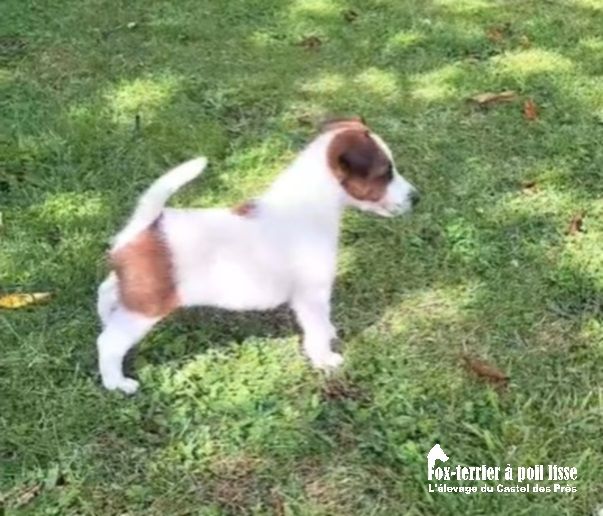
[322,118,419,217]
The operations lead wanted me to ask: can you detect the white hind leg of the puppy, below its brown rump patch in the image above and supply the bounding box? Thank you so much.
[96,307,160,394]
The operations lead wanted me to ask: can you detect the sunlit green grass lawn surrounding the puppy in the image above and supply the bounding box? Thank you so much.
[0,0,603,515]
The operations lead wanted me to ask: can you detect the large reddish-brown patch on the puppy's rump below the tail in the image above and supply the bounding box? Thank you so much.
[111,219,179,317]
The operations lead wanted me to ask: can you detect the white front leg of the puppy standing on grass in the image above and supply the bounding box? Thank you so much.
[291,288,343,369]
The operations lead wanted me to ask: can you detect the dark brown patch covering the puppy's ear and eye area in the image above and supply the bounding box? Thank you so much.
[327,127,393,202]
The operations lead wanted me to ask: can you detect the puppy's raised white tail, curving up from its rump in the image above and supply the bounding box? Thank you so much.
[112,158,207,251]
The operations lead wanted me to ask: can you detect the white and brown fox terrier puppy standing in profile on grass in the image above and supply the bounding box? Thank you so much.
[97,119,418,393]
